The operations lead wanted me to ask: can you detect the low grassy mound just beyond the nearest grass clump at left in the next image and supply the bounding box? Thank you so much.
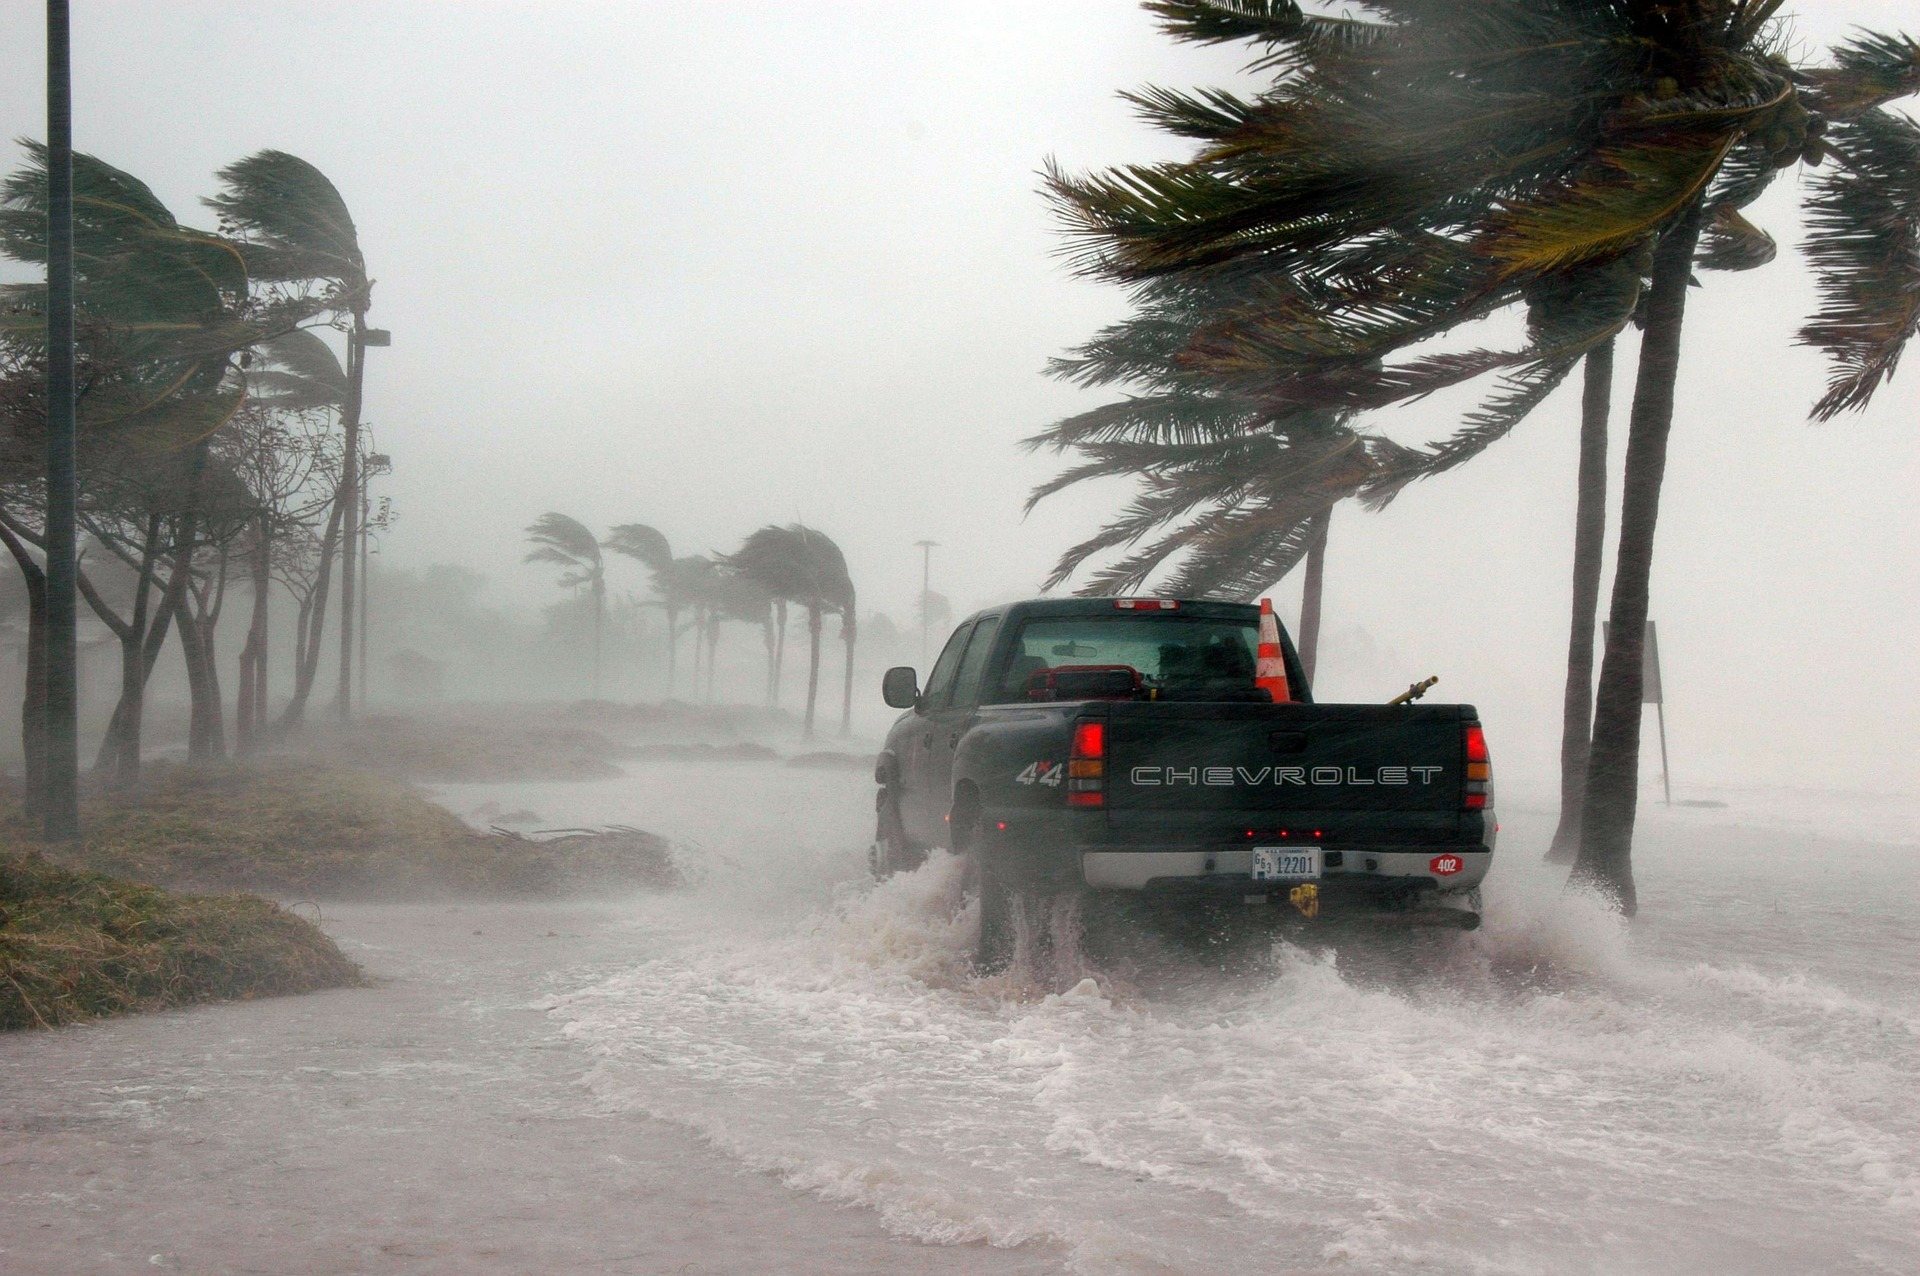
[0,758,678,898]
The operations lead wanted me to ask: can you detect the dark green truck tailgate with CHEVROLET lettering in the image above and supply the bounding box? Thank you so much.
[1104,700,1475,835]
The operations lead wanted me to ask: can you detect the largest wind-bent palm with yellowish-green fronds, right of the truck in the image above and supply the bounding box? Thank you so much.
[1052,0,1920,911]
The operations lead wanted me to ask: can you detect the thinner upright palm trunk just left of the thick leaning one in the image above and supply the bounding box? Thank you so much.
[1548,340,1613,863]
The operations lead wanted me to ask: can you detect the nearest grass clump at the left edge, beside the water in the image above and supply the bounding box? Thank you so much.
[0,852,365,1028]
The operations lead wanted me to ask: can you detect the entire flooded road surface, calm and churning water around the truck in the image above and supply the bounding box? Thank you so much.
[0,762,1920,1272]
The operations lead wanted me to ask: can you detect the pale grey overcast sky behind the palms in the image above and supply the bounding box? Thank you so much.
[0,0,1920,791]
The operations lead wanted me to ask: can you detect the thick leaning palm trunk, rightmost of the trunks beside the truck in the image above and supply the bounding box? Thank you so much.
[1574,205,1701,917]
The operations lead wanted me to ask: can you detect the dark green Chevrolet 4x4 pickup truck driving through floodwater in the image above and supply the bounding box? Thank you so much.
[872,599,1498,969]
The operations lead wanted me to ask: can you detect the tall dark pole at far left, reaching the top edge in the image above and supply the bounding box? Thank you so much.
[42,0,81,842]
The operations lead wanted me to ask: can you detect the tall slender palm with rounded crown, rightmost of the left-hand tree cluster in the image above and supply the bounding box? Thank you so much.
[205,150,372,718]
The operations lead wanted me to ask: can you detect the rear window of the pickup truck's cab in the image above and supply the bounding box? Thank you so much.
[983,612,1260,704]
